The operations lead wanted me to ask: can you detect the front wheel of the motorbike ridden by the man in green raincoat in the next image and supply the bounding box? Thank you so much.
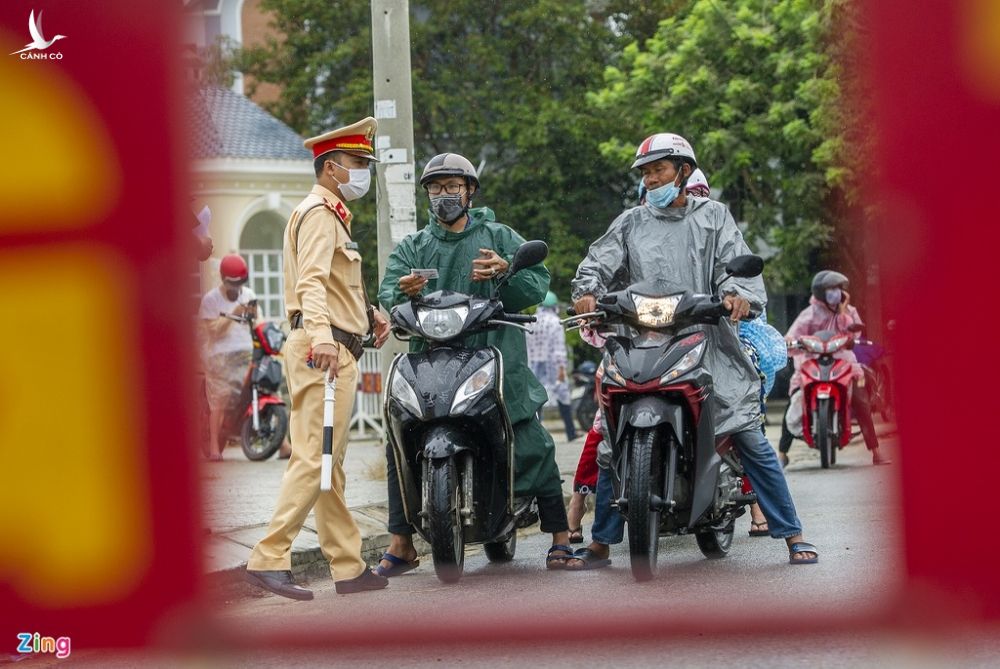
[427,456,465,583]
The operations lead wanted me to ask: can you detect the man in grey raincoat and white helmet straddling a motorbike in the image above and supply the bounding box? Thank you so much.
[569,133,818,569]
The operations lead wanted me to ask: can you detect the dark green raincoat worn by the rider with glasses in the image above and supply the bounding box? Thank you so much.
[378,207,562,496]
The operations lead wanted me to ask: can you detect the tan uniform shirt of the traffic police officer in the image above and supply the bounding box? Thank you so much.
[284,184,368,348]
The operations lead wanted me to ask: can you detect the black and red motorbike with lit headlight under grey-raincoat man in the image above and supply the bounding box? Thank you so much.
[564,256,763,581]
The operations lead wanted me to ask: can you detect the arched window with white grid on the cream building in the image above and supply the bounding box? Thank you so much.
[240,211,285,320]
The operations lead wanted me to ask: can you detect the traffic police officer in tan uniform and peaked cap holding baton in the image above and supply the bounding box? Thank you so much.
[246,117,389,600]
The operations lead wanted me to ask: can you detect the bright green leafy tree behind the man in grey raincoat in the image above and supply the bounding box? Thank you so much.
[590,0,850,288]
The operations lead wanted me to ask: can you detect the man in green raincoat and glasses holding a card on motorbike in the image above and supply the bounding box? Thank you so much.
[376,153,572,576]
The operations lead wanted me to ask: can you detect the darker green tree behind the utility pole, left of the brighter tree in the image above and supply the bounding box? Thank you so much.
[237,0,683,299]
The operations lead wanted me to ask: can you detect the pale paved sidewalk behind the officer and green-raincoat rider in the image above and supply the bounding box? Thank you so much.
[200,420,584,585]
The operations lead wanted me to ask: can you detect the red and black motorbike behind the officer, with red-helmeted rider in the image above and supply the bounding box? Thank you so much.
[202,314,288,460]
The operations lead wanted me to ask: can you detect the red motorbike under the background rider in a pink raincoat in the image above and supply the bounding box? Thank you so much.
[788,327,860,469]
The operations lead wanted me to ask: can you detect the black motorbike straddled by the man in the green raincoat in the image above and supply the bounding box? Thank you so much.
[384,241,548,583]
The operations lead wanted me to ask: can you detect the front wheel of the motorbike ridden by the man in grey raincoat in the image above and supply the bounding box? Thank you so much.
[625,428,663,581]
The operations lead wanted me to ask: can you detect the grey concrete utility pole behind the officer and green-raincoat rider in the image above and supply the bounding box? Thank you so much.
[372,0,417,396]
